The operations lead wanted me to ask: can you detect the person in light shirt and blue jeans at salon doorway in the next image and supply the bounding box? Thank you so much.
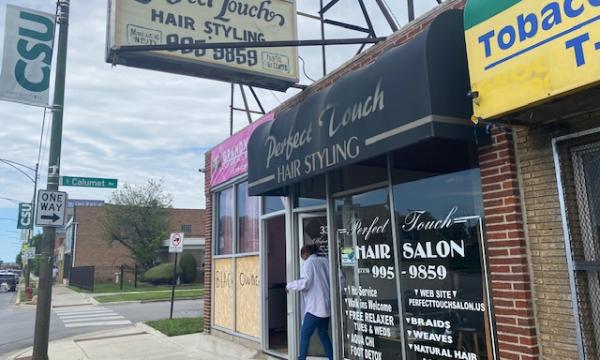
[286,244,333,360]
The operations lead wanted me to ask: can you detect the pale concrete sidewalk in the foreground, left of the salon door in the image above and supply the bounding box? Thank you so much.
[6,323,273,360]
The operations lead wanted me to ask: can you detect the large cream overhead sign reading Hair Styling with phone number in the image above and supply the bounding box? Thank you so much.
[106,0,298,90]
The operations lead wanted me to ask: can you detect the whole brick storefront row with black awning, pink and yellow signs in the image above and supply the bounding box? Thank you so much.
[200,0,600,360]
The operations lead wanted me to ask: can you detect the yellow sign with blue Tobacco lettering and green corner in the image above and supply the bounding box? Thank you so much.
[465,0,600,119]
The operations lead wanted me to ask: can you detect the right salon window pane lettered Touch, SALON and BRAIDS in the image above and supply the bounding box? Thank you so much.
[398,207,495,360]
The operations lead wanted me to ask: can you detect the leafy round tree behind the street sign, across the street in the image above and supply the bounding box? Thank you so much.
[100,180,171,269]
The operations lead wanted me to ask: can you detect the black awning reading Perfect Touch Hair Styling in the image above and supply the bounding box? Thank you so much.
[248,10,486,195]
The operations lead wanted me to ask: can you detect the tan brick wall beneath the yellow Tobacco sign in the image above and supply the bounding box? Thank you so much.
[516,113,600,360]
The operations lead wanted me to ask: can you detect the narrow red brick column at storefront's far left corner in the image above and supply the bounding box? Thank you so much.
[204,151,213,334]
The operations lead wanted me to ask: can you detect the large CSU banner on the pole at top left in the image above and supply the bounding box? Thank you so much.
[0,5,55,106]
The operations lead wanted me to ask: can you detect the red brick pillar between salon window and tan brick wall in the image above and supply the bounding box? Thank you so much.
[479,131,540,360]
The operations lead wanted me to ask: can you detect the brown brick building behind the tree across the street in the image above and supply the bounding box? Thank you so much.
[64,206,205,281]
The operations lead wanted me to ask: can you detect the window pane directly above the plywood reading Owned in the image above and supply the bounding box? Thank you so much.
[237,182,260,253]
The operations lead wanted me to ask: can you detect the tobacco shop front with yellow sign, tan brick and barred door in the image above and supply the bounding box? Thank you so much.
[465,0,600,359]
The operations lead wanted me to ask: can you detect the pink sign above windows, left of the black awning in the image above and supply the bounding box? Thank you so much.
[210,113,273,187]
